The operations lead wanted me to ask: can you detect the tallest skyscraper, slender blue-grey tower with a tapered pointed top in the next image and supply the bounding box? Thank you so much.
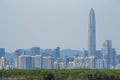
[88,8,96,56]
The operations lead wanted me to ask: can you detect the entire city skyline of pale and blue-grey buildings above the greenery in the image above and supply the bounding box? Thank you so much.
[0,8,120,69]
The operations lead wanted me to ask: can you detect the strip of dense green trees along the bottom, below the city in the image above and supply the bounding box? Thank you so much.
[0,69,120,80]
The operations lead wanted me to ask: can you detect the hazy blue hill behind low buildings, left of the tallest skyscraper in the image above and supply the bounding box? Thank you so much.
[60,49,83,57]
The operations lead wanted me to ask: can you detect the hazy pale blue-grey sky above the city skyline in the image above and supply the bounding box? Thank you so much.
[0,0,120,52]
